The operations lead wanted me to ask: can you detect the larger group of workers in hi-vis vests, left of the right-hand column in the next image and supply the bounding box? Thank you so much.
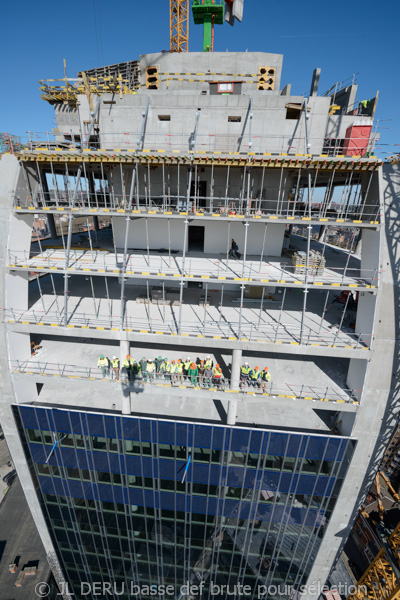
[97,354,224,388]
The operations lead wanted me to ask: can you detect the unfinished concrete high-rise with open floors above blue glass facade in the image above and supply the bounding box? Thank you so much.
[0,53,398,598]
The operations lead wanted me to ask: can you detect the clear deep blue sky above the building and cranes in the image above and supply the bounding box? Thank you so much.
[0,0,400,157]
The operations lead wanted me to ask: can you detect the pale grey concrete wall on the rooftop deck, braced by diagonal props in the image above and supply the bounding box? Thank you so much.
[100,90,330,154]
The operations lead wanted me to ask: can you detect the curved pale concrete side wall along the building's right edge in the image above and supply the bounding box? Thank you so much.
[302,165,400,600]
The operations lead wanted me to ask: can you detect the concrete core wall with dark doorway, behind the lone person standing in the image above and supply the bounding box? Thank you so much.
[112,217,285,256]
